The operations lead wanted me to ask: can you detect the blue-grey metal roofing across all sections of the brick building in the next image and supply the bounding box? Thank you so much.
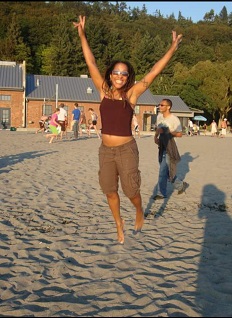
[0,61,191,113]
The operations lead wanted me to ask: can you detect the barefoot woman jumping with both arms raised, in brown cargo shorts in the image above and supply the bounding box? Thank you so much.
[73,16,182,244]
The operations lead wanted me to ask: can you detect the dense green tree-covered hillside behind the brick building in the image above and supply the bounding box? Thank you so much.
[0,1,232,121]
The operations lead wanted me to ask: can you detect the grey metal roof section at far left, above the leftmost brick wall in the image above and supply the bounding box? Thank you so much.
[0,61,23,90]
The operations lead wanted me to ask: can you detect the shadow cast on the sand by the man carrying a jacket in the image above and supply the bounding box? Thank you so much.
[144,152,199,217]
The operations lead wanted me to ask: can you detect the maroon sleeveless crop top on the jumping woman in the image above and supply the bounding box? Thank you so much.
[100,97,134,136]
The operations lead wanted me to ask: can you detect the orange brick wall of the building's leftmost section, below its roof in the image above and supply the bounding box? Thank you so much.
[0,90,24,127]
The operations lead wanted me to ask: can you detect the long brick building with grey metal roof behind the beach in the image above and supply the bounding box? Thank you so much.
[0,61,194,131]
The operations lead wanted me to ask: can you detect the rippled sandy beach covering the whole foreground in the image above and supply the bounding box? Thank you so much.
[0,131,232,317]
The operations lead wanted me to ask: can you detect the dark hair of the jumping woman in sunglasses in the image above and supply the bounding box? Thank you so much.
[102,60,135,97]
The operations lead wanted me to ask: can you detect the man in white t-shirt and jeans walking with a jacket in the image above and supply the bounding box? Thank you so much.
[153,98,187,200]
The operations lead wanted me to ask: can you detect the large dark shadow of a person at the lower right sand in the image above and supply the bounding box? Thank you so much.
[195,184,232,317]
